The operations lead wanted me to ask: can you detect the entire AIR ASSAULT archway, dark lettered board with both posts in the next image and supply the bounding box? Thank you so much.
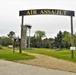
[19,9,75,58]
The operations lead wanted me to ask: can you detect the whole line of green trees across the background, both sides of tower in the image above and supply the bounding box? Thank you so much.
[0,30,76,48]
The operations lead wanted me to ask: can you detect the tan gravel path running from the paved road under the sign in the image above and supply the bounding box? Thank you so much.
[18,53,76,73]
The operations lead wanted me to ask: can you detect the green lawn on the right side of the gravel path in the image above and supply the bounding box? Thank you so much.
[26,48,76,62]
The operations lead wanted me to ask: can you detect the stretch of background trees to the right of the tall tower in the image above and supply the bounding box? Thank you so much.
[31,31,76,48]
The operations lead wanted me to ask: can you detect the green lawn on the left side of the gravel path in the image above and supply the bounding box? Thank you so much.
[0,47,35,61]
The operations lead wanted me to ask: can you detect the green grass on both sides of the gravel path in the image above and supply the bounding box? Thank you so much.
[0,47,76,62]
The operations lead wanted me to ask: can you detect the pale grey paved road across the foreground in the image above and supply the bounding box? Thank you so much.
[0,60,76,75]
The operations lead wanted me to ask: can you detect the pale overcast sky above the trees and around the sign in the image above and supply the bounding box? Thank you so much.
[0,0,76,37]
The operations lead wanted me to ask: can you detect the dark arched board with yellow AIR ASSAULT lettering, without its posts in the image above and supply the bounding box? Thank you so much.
[19,9,75,16]
